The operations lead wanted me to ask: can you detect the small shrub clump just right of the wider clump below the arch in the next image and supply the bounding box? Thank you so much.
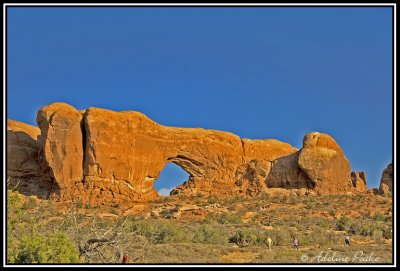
[193,225,228,244]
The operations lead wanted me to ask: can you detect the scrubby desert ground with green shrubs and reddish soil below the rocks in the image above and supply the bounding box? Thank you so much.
[7,190,392,264]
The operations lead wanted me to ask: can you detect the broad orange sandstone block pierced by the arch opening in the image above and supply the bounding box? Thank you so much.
[84,108,243,204]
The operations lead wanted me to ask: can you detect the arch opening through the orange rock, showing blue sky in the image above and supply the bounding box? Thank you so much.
[154,162,190,196]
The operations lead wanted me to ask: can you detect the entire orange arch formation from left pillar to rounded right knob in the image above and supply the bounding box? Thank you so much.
[7,103,358,204]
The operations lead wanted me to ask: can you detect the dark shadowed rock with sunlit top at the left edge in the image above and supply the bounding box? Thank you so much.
[7,120,52,199]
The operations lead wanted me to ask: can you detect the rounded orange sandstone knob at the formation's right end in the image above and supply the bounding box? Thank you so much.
[298,132,352,195]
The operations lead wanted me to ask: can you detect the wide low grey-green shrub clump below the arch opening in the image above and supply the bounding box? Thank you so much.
[131,220,190,244]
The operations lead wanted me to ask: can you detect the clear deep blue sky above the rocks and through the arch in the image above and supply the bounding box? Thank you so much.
[7,7,393,193]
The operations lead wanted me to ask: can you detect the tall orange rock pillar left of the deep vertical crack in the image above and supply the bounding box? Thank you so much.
[36,103,83,198]
